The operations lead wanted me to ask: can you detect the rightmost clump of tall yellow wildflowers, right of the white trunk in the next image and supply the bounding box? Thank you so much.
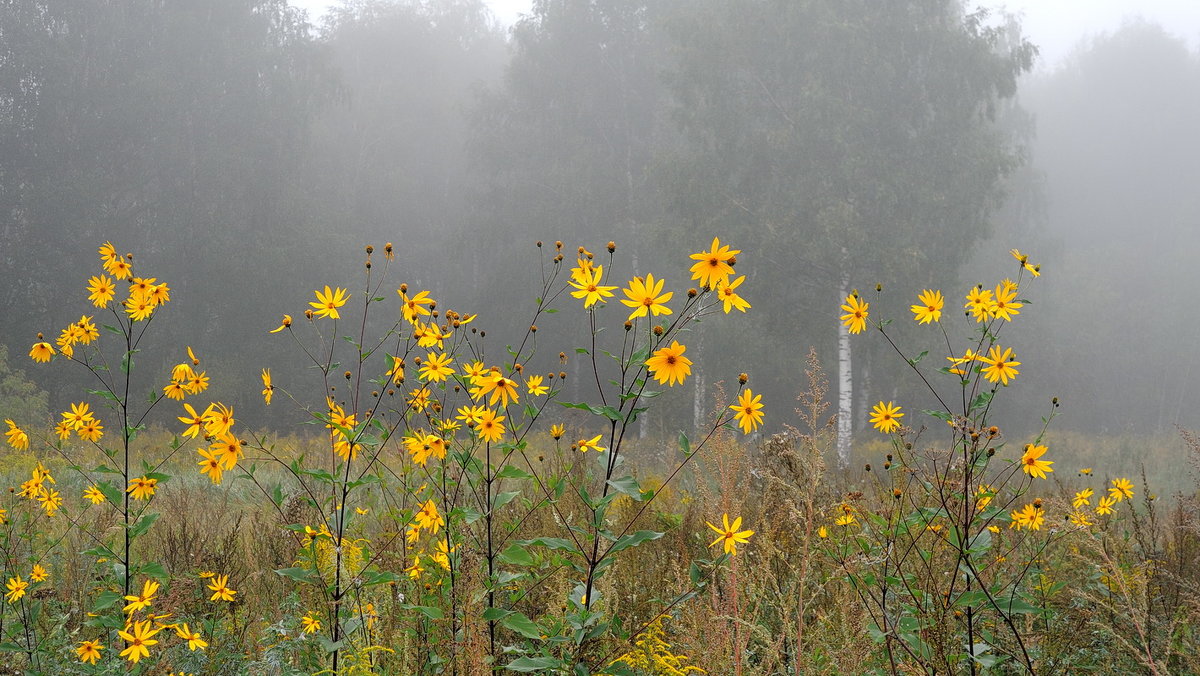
[826,250,1133,674]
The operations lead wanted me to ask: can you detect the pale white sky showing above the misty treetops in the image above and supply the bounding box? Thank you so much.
[290,0,1200,67]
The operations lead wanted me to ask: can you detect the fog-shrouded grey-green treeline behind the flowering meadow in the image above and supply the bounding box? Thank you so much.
[0,0,1200,435]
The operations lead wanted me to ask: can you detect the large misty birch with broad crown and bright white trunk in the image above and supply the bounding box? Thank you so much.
[665,0,1034,463]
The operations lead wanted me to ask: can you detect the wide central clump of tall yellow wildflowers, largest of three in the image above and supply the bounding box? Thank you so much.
[234,240,763,674]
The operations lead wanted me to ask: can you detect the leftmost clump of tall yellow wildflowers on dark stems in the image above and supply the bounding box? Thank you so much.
[9,243,241,671]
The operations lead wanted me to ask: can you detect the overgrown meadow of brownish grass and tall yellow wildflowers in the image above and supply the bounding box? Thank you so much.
[0,239,1200,676]
